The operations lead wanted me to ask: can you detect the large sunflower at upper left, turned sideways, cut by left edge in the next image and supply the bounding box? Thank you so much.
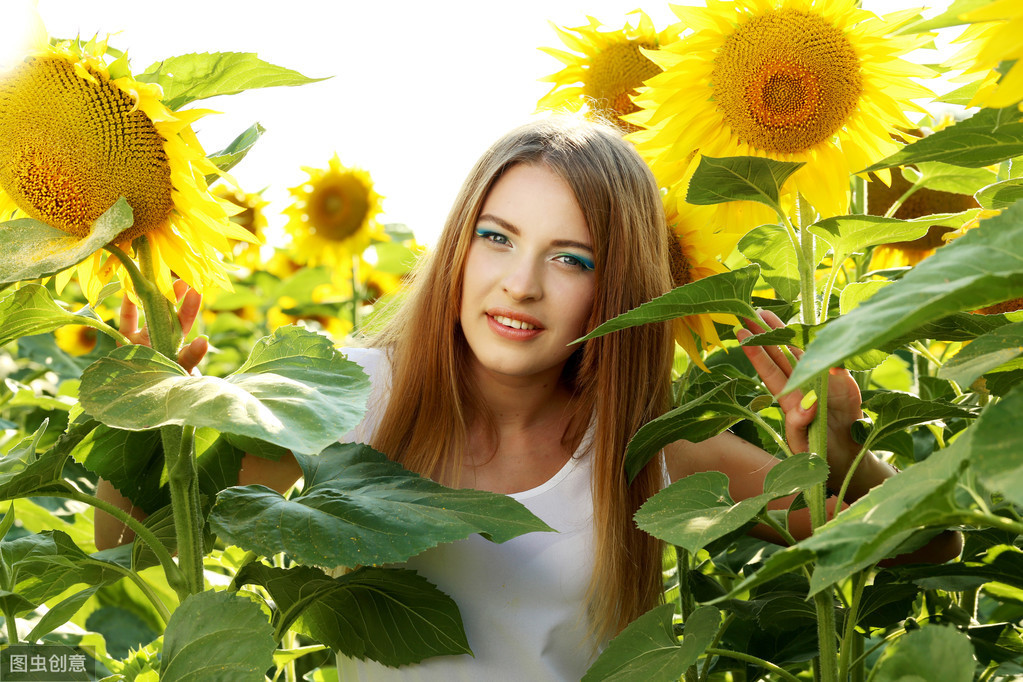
[0,16,255,301]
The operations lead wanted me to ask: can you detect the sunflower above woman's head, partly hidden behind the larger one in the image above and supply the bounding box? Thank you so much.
[537,10,678,131]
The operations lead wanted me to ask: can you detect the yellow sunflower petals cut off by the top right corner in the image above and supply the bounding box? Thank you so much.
[945,0,1023,108]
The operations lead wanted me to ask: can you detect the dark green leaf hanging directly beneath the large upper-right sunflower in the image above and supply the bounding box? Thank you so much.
[685,156,803,213]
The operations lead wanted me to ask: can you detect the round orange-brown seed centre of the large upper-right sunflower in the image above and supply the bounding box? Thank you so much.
[711,9,862,153]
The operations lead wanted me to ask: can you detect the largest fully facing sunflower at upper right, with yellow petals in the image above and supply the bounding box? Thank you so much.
[626,0,932,231]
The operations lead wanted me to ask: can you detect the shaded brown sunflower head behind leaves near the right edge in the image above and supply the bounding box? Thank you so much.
[866,174,980,270]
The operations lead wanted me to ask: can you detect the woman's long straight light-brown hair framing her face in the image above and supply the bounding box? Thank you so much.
[371,118,673,639]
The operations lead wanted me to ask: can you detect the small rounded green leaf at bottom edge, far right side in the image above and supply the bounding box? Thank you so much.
[875,625,977,682]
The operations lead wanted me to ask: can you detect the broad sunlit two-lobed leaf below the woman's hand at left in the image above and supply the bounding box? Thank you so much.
[80,326,369,453]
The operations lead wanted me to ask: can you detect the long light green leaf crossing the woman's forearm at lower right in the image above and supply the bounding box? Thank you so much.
[798,437,970,594]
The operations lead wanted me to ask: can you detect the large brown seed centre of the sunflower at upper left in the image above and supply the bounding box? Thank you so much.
[0,55,173,240]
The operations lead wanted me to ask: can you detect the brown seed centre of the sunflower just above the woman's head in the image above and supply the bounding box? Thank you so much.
[582,41,661,130]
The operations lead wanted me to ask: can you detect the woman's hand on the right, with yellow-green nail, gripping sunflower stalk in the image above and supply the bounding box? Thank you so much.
[736,311,894,499]
